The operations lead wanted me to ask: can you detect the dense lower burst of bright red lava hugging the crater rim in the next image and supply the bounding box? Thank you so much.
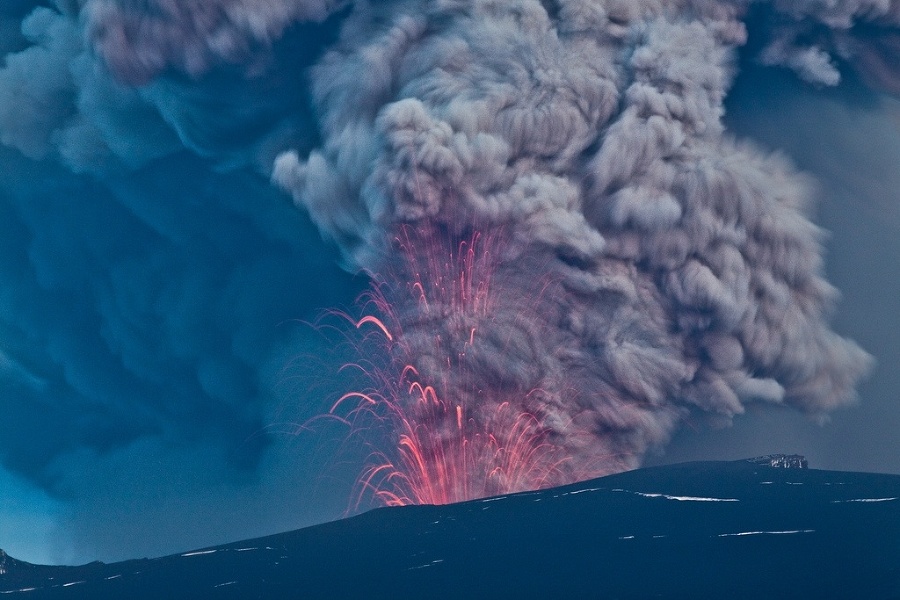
[334,358,567,506]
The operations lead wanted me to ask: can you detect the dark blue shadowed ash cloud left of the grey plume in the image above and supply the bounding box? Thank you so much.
[0,2,357,498]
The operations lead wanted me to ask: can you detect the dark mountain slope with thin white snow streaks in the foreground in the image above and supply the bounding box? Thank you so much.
[0,461,900,600]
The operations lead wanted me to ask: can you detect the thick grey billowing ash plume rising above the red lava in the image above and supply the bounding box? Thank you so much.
[274,0,872,492]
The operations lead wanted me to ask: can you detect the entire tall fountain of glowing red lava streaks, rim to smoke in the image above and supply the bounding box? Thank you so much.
[331,227,614,508]
